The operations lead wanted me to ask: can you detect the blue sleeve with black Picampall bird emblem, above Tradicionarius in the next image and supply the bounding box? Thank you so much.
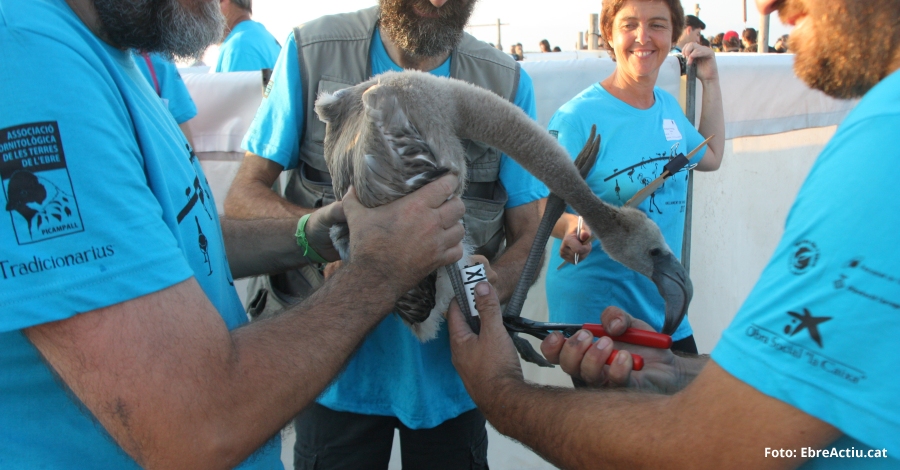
[0,34,193,331]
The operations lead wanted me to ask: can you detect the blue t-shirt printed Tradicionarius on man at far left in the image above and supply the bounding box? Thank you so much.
[0,0,281,469]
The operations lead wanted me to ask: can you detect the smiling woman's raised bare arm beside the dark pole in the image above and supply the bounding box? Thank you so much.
[682,42,725,171]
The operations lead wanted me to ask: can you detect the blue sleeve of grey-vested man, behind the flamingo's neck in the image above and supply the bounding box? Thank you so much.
[500,69,550,209]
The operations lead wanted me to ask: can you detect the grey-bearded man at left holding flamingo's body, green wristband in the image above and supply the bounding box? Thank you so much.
[0,0,465,469]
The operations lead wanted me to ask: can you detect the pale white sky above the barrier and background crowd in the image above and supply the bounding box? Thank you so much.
[253,0,790,52]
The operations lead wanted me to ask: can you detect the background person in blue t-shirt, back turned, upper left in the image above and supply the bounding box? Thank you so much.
[216,0,281,72]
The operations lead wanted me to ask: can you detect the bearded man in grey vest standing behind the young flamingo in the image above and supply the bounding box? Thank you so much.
[225,0,547,469]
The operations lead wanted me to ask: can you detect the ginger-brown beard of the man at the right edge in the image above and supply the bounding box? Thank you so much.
[779,0,900,99]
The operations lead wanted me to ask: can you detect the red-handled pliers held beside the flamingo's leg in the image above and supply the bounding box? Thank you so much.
[503,316,672,370]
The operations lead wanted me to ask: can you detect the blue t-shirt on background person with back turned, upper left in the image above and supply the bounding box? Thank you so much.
[216,20,281,72]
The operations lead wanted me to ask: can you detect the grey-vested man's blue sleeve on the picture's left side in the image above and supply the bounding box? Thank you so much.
[242,34,304,169]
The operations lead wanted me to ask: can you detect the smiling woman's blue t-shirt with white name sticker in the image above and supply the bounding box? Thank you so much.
[546,83,706,341]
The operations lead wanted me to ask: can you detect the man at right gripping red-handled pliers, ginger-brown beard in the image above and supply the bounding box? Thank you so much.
[449,0,900,469]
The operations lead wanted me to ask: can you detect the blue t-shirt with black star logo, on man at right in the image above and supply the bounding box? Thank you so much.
[712,72,900,468]
